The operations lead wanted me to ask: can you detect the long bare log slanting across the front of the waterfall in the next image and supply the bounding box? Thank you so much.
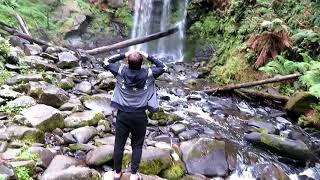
[86,26,179,55]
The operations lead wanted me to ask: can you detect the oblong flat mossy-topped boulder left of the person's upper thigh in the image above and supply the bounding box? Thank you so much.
[64,111,105,128]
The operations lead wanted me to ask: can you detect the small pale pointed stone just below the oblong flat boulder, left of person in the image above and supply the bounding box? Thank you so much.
[70,126,98,144]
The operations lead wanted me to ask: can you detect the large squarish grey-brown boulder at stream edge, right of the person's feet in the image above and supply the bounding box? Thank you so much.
[180,138,229,177]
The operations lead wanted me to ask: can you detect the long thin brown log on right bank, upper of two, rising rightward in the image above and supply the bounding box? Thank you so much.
[203,73,302,94]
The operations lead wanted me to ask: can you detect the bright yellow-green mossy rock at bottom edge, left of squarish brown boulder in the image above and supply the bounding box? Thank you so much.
[161,162,187,180]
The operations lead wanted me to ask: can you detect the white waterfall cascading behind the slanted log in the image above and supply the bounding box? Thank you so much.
[130,0,188,62]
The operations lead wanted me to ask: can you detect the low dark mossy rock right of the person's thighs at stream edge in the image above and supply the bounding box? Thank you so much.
[148,110,180,126]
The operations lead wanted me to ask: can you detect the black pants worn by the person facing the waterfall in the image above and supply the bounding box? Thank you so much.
[113,110,148,174]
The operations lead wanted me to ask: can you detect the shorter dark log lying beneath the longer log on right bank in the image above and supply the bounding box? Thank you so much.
[238,89,289,103]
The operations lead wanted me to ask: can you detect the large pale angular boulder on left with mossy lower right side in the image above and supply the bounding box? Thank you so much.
[21,104,64,132]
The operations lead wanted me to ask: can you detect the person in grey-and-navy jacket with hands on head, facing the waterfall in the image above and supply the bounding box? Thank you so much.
[104,51,167,180]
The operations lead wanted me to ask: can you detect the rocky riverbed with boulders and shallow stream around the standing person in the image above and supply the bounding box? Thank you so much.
[0,37,320,180]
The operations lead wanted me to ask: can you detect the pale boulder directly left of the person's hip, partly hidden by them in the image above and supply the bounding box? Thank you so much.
[81,94,114,116]
